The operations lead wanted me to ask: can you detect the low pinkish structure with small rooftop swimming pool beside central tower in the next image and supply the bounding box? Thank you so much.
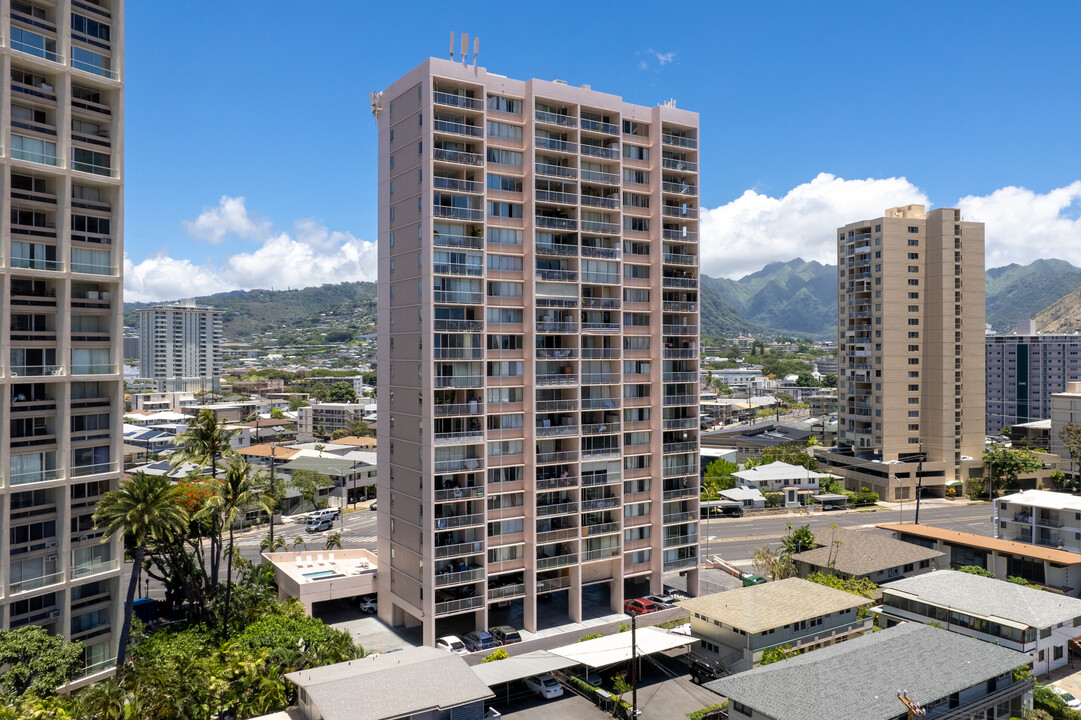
[263,548,377,615]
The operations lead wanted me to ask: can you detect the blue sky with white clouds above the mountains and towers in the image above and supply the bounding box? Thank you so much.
[125,0,1081,299]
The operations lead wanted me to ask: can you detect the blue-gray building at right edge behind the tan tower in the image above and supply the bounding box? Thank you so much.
[984,320,1081,432]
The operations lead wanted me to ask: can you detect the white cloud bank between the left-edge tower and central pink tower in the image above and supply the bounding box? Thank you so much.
[124,197,377,302]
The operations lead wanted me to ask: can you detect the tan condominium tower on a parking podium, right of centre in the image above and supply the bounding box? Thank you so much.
[820,205,985,501]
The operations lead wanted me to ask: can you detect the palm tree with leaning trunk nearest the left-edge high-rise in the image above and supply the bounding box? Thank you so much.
[93,471,188,680]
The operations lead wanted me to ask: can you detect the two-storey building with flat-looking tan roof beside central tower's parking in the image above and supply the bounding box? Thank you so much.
[679,577,871,672]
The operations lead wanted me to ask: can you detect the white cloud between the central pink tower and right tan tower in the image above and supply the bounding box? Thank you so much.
[700,173,929,278]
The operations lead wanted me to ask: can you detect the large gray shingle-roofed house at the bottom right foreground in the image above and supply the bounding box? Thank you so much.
[705,623,1032,720]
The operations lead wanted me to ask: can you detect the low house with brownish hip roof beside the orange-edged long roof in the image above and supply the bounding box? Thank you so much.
[791,529,946,585]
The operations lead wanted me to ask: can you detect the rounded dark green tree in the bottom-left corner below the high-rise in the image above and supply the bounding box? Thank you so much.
[0,625,82,697]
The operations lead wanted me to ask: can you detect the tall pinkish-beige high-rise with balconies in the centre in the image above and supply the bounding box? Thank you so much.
[372,53,698,644]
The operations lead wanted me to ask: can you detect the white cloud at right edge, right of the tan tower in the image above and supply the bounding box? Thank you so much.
[957,181,1081,267]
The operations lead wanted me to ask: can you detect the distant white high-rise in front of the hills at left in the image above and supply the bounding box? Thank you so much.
[138,301,224,392]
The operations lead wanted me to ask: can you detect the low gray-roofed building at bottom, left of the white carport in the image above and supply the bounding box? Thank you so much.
[285,648,495,720]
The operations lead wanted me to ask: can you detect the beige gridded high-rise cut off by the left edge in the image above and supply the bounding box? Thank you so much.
[0,0,124,681]
